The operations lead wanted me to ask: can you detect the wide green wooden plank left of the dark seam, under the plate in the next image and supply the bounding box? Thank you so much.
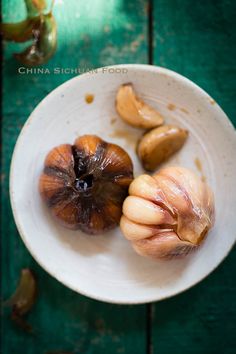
[1,0,148,354]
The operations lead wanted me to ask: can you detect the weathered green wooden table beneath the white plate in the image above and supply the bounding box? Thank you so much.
[1,0,236,354]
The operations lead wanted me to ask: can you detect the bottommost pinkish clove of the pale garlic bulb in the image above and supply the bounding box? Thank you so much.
[132,230,196,259]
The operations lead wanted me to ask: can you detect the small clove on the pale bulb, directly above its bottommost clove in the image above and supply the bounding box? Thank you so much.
[120,215,158,241]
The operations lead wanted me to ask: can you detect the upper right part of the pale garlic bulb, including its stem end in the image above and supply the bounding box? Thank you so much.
[153,167,214,245]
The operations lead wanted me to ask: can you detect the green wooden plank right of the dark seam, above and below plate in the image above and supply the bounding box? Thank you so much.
[151,0,236,354]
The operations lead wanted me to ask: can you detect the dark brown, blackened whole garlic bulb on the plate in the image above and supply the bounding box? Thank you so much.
[39,135,133,234]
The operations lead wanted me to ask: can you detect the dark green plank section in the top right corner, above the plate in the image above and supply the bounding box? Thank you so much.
[154,0,236,125]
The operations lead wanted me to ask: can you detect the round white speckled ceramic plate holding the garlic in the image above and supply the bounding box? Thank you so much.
[10,65,236,304]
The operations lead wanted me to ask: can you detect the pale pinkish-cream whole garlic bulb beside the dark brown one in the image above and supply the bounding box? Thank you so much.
[120,167,214,258]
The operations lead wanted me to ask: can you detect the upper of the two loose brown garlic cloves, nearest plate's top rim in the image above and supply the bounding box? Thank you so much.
[116,83,164,129]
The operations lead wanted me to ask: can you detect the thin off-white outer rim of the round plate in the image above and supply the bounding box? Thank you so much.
[9,64,236,305]
